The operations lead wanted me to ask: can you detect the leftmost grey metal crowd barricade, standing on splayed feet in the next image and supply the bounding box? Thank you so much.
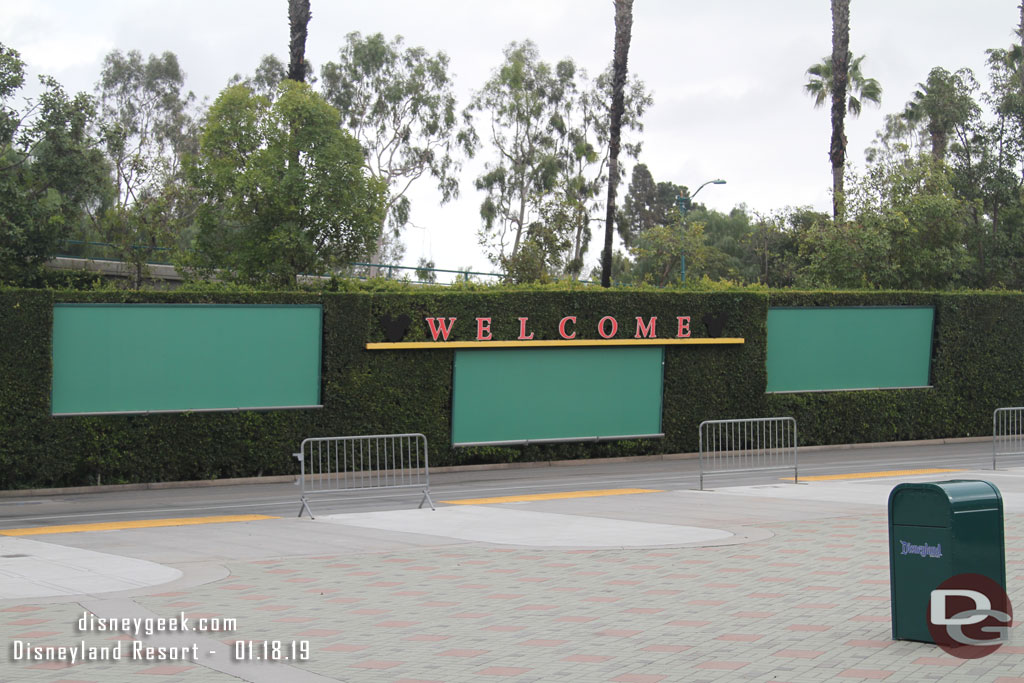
[292,434,434,518]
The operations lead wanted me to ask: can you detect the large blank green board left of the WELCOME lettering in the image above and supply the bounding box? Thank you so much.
[51,304,322,415]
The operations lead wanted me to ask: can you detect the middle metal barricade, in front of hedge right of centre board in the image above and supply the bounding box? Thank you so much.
[699,418,797,490]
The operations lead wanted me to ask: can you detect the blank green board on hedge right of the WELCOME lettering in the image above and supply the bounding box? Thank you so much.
[767,306,935,391]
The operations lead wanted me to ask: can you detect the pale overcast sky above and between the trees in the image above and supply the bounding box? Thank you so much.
[0,0,1020,280]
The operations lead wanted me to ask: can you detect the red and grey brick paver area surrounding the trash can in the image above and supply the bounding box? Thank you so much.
[6,505,1024,683]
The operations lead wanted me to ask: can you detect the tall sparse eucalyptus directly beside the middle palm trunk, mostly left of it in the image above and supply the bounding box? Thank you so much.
[467,36,651,276]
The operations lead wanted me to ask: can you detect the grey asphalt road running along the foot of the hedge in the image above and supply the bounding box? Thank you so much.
[0,440,1007,529]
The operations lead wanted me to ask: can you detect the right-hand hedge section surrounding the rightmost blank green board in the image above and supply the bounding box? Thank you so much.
[767,292,1024,445]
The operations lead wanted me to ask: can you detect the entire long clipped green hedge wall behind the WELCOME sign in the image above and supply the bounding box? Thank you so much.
[0,288,1024,488]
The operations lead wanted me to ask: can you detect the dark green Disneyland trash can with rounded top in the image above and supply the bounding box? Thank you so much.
[889,479,1007,643]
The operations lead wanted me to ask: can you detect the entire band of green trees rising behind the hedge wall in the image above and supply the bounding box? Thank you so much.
[6,6,1024,289]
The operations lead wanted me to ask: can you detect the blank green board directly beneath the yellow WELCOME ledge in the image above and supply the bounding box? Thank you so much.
[452,346,664,445]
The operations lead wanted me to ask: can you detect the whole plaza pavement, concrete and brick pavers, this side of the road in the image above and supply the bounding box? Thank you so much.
[0,470,1024,683]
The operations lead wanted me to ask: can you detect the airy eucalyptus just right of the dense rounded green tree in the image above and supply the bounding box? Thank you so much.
[321,33,476,272]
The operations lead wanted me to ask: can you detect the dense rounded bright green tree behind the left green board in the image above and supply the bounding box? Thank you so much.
[193,81,386,288]
